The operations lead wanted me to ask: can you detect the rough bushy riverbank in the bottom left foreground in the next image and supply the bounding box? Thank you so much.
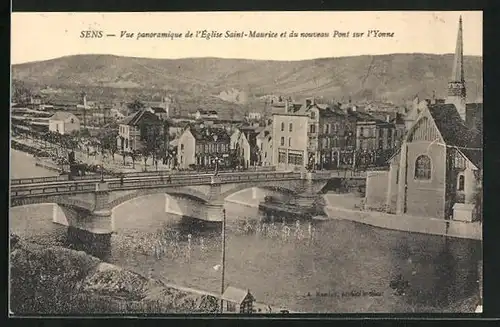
[10,234,292,315]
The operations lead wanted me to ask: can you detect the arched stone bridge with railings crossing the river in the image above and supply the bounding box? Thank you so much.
[10,172,364,258]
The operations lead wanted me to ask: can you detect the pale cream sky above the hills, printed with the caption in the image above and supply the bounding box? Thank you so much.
[11,11,483,64]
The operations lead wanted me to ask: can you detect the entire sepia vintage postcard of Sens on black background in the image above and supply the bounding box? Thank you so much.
[9,11,483,316]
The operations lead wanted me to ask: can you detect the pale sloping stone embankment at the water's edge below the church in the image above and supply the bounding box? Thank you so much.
[324,194,483,240]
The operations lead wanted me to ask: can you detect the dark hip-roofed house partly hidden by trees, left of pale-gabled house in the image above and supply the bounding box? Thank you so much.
[117,110,163,153]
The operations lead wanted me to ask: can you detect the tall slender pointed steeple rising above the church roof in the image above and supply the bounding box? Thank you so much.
[446,16,466,121]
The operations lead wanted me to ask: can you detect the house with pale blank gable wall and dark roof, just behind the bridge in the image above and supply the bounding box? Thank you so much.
[177,126,233,169]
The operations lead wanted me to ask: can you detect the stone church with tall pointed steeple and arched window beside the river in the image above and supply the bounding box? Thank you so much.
[366,18,482,221]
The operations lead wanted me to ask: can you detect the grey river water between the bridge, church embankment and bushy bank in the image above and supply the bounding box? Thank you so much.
[11,150,481,313]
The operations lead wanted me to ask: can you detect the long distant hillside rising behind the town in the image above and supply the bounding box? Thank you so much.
[12,54,482,111]
